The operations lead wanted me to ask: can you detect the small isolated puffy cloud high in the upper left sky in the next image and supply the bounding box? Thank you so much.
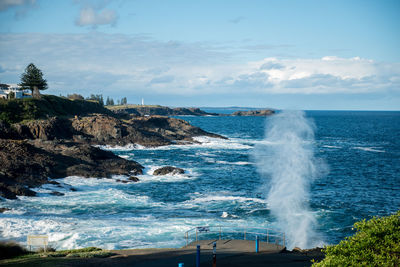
[75,7,118,27]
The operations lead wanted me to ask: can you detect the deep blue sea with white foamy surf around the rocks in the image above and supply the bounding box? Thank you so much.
[0,110,400,249]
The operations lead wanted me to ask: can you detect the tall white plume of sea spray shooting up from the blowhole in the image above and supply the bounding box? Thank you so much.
[254,111,326,249]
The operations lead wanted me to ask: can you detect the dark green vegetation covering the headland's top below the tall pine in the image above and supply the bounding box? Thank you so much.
[0,95,111,123]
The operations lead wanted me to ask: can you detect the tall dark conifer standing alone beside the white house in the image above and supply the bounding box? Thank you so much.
[19,63,47,98]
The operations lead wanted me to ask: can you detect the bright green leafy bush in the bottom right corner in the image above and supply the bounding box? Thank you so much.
[313,211,400,266]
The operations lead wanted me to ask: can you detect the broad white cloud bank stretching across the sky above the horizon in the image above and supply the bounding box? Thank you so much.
[0,33,400,96]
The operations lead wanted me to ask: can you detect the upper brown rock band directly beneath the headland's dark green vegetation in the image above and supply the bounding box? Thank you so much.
[5,114,225,147]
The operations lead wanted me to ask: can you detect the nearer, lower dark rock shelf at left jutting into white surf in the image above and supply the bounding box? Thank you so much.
[0,139,143,199]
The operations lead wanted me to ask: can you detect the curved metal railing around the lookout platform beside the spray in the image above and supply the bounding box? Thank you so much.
[185,225,286,246]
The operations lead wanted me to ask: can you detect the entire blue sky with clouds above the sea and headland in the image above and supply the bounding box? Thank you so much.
[0,0,400,110]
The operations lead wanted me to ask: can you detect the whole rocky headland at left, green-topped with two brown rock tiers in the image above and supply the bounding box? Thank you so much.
[0,96,225,199]
